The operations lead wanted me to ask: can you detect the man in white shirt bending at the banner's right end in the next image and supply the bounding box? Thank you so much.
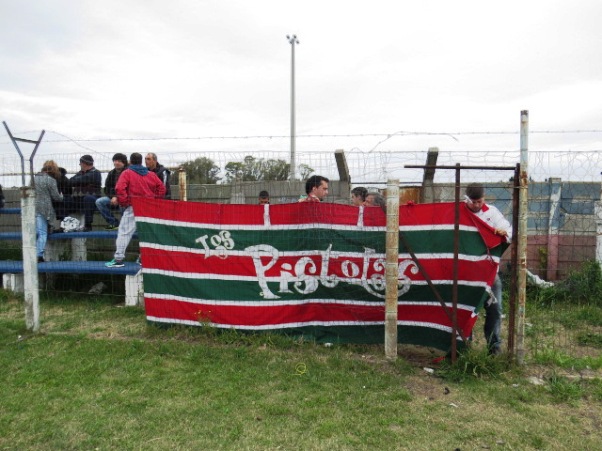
[466,183,512,355]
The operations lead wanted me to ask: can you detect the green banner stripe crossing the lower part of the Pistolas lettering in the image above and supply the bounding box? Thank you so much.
[144,274,486,307]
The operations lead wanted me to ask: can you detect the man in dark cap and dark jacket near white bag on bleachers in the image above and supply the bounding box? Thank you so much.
[69,155,102,232]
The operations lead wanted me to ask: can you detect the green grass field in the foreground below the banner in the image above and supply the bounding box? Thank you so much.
[0,290,602,450]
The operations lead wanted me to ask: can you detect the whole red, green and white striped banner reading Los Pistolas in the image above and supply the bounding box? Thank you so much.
[134,199,506,350]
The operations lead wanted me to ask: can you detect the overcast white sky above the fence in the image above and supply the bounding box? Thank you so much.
[0,0,602,184]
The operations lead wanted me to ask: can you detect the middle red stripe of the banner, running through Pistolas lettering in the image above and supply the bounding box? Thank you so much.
[142,247,496,285]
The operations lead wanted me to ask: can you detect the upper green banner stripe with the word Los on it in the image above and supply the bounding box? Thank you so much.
[137,222,502,256]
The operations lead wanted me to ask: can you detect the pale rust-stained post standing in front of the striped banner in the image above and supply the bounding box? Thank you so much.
[385,179,399,360]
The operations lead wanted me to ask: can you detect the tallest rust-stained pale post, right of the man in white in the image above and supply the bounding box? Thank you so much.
[516,110,529,365]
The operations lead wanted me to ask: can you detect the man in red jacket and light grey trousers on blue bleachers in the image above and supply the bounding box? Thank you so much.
[105,152,165,268]
